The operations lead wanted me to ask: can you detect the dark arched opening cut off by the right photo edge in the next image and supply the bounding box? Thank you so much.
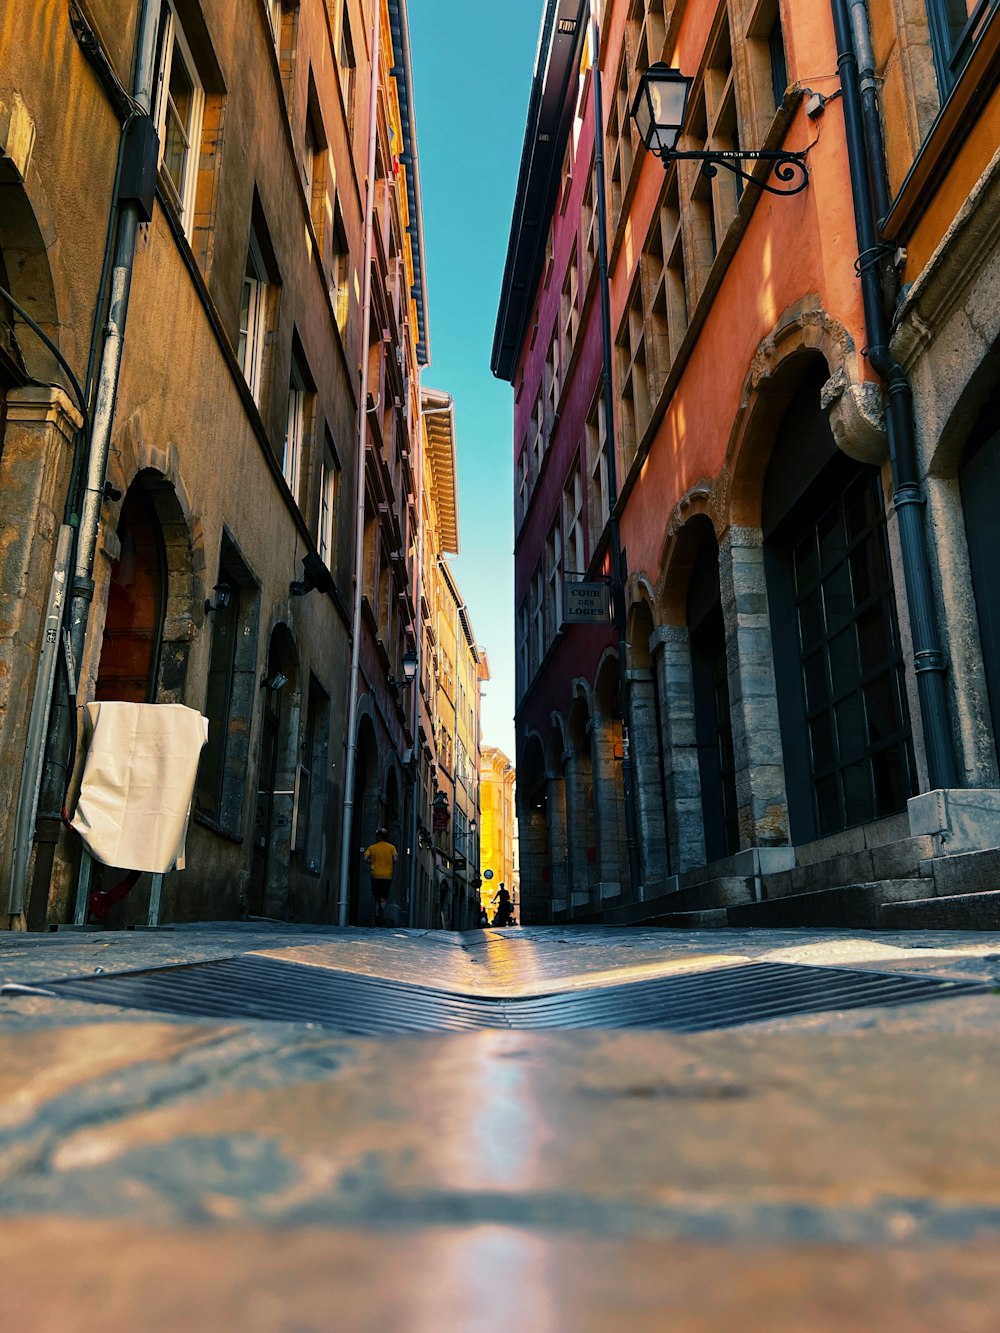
[959,391,1000,757]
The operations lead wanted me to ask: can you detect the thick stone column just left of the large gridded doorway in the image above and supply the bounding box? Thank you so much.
[719,528,788,848]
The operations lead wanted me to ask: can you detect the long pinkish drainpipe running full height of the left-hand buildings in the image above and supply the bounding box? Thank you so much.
[337,0,381,925]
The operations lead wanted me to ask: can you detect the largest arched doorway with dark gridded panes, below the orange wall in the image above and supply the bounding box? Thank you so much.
[763,363,915,842]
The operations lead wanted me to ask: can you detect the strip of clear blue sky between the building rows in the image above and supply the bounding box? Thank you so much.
[408,0,543,758]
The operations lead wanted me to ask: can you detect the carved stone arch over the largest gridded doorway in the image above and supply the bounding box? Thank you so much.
[713,297,887,531]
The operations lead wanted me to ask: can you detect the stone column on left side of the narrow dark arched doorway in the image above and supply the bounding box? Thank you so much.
[649,625,705,874]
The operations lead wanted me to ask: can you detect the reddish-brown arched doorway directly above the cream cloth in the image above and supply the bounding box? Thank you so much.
[95,481,167,704]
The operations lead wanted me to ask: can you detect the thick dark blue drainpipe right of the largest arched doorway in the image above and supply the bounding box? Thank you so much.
[831,0,959,790]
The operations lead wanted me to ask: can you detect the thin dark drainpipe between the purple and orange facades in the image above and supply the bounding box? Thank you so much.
[592,4,644,902]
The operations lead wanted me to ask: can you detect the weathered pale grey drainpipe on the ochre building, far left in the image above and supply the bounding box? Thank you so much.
[69,0,160,672]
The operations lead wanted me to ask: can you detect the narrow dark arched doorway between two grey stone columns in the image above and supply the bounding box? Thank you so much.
[687,519,740,861]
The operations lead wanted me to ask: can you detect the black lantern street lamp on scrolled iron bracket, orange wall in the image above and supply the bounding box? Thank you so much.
[632,60,809,195]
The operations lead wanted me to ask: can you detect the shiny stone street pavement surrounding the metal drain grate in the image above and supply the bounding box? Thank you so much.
[0,924,1000,1333]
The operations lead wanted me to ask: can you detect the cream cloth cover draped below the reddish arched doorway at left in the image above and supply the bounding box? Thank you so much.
[72,702,208,873]
